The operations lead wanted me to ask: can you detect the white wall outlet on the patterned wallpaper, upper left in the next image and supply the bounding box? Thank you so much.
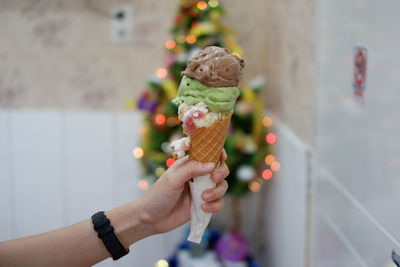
[110,4,134,43]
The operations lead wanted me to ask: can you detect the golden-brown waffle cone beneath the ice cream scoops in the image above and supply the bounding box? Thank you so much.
[189,114,232,164]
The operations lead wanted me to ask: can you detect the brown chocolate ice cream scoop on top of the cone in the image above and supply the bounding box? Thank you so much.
[182,46,244,87]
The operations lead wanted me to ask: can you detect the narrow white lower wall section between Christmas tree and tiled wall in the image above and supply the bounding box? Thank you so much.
[264,120,311,267]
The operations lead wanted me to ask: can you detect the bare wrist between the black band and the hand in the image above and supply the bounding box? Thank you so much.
[106,202,154,249]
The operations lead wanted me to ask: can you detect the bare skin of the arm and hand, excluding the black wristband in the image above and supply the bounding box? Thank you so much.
[0,151,229,266]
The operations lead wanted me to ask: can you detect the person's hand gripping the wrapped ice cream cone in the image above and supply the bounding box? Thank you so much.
[137,150,229,234]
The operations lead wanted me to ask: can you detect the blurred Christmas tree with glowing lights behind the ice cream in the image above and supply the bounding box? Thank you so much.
[133,0,279,195]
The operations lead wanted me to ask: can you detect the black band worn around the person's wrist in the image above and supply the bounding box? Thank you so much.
[92,211,129,260]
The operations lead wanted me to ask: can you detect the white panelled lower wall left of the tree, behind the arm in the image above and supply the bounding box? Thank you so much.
[0,110,183,267]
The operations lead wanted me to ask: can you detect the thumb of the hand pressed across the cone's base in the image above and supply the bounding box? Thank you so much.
[168,161,215,186]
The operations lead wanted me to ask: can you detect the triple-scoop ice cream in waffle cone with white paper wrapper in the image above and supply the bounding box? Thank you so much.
[170,46,244,243]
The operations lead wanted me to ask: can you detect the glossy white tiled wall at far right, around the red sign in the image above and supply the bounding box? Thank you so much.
[312,0,400,267]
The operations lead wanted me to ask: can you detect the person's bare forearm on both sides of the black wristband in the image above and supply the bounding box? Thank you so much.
[0,203,152,266]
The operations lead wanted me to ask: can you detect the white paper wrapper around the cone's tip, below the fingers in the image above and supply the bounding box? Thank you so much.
[188,174,215,243]
